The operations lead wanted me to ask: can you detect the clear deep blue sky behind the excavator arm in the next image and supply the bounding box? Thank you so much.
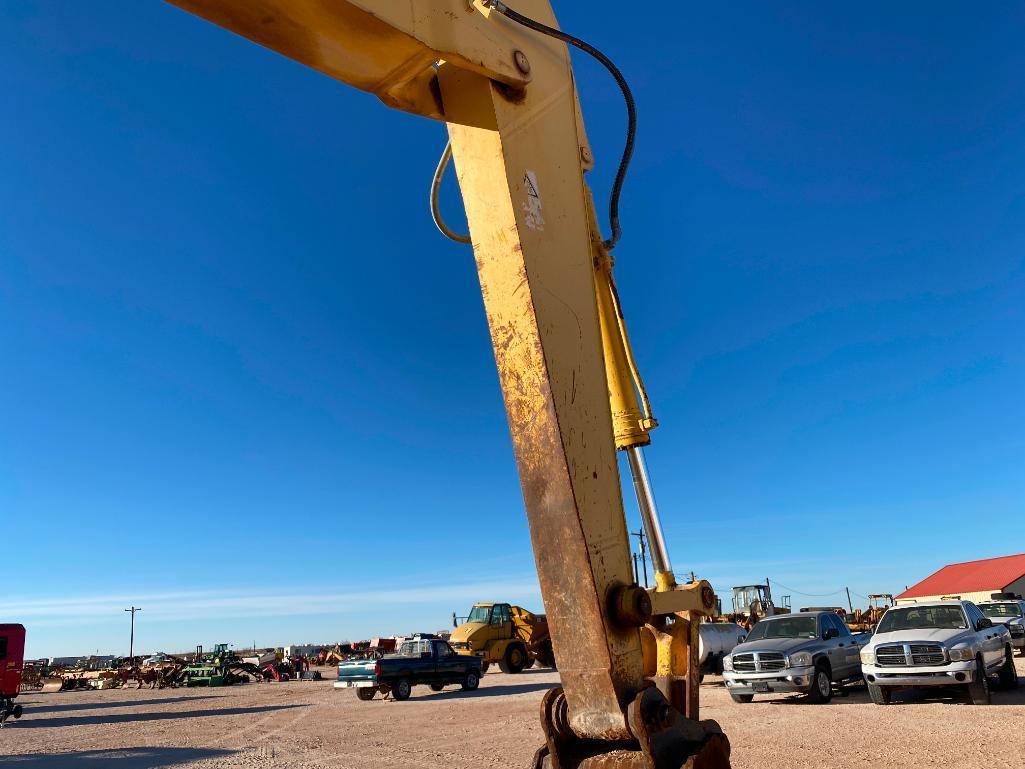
[0,0,1025,655]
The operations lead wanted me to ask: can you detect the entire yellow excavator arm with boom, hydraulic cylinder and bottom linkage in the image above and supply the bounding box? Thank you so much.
[164,0,729,769]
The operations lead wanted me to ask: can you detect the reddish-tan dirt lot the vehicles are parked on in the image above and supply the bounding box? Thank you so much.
[0,658,1025,769]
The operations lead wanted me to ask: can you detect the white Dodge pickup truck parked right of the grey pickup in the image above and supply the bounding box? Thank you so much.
[861,601,1018,705]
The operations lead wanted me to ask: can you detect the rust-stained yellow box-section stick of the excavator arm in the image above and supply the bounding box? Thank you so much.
[439,0,644,740]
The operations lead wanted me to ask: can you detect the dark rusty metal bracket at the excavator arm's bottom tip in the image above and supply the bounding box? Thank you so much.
[531,687,730,769]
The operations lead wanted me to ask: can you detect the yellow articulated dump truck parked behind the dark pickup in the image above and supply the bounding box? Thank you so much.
[449,604,556,673]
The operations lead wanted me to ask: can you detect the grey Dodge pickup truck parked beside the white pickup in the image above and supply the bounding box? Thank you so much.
[723,611,869,702]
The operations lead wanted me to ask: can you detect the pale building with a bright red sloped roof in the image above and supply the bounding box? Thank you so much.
[894,553,1025,604]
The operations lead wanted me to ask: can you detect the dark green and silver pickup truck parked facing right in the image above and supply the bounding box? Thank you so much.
[334,636,481,700]
